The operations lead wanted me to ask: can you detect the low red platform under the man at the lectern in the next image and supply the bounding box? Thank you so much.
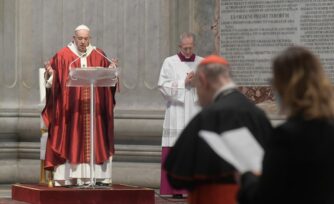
[12,184,154,204]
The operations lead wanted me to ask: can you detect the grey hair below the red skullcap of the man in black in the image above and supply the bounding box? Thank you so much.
[198,64,230,81]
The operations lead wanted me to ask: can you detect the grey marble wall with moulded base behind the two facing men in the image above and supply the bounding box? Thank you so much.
[0,0,219,187]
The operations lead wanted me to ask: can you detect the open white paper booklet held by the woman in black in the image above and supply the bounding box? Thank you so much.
[199,127,264,173]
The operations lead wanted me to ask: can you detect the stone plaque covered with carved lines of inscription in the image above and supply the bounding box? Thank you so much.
[220,0,334,86]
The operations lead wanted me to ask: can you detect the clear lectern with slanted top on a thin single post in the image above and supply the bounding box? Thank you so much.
[66,67,118,188]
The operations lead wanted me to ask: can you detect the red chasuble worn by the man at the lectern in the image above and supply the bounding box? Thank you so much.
[42,47,115,170]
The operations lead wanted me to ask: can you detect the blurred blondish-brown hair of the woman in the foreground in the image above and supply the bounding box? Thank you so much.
[272,46,334,119]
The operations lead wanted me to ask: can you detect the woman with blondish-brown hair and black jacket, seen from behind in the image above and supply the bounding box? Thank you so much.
[239,47,334,204]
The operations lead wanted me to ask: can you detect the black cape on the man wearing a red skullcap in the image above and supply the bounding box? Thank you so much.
[165,89,272,190]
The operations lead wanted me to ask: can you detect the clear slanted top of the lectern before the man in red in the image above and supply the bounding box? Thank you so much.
[67,67,119,87]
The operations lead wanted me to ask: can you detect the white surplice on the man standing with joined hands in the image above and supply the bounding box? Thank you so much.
[158,55,203,147]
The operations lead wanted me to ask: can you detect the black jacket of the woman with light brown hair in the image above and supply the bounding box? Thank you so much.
[239,117,334,204]
